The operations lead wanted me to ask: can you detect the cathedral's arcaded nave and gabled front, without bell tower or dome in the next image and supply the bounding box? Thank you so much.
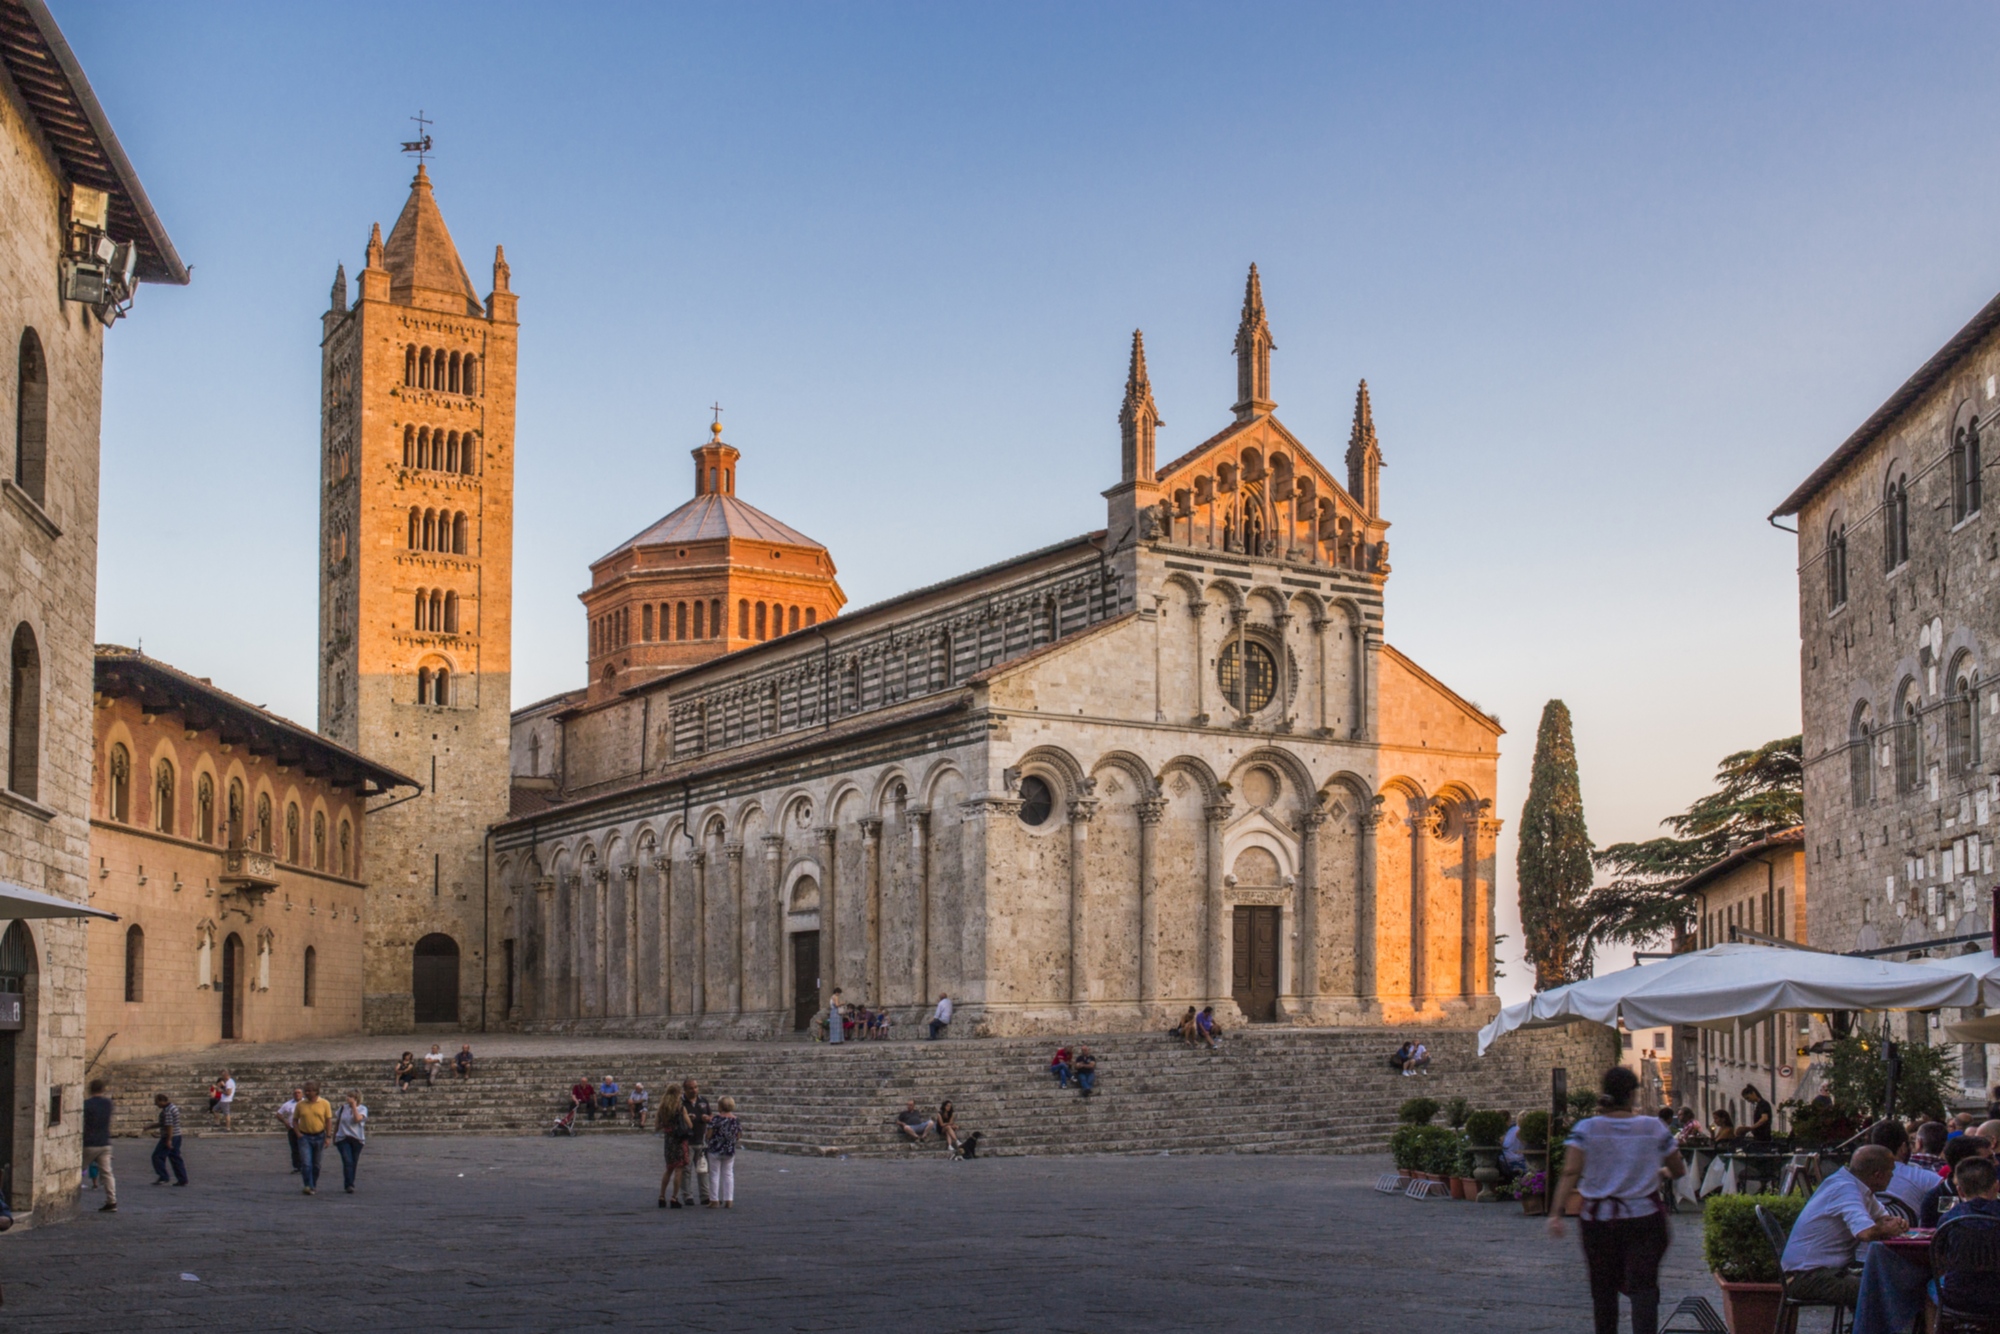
[492,268,1500,1036]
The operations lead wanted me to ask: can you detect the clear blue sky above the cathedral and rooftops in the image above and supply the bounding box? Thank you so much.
[56,0,2000,990]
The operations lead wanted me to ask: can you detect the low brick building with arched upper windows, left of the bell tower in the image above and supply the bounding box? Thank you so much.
[88,644,416,1060]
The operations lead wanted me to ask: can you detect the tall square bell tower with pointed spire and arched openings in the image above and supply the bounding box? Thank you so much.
[320,166,518,1032]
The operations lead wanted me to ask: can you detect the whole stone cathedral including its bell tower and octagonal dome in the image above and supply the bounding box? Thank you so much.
[320,170,1500,1038]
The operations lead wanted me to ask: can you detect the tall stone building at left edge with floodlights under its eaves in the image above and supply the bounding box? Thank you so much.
[0,0,188,1216]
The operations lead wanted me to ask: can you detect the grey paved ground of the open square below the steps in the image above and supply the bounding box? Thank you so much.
[0,1132,1720,1334]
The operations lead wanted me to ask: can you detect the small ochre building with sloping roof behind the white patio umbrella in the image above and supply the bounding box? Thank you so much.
[1672,828,1818,1122]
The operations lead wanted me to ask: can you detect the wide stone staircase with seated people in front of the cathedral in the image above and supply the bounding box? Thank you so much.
[110,1028,1614,1156]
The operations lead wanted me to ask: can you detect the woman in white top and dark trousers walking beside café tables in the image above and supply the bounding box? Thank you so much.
[1548,1066,1688,1334]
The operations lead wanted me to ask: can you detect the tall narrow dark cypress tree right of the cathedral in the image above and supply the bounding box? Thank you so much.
[1514,700,1594,992]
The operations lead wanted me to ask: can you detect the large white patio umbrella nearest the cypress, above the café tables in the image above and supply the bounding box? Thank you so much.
[1480,942,1980,1056]
